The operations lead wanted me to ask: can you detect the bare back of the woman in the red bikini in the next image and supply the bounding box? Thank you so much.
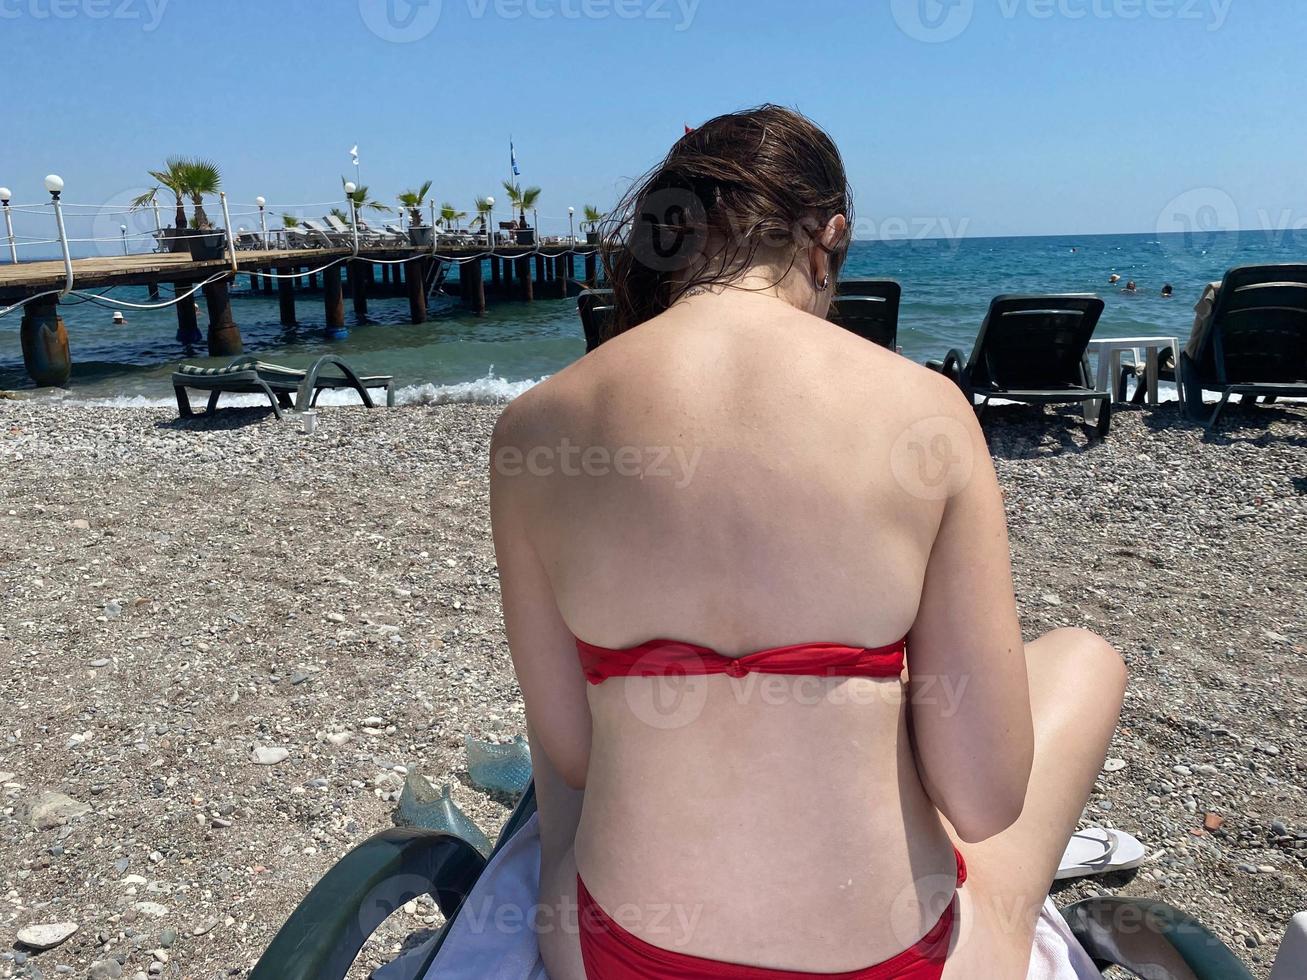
[495,293,1035,972]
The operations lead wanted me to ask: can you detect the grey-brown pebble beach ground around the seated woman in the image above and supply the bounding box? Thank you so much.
[0,400,1307,980]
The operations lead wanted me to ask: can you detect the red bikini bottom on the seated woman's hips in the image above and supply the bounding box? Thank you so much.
[576,852,967,980]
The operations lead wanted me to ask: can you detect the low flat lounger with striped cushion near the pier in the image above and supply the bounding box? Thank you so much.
[173,354,395,418]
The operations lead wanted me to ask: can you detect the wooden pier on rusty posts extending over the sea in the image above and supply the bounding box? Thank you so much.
[0,242,597,385]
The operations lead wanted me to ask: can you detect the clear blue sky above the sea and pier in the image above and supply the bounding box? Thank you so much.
[0,0,1307,238]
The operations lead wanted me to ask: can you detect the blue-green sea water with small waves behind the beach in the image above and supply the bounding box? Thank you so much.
[0,233,1307,405]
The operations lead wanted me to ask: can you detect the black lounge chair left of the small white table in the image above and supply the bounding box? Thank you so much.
[927,294,1112,439]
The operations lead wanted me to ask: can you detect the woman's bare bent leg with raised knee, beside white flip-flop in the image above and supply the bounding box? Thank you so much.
[944,630,1125,980]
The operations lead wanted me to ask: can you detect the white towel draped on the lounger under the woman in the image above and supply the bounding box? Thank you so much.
[372,815,1102,980]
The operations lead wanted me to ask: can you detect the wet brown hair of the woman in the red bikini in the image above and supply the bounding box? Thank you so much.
[604,105,853,340]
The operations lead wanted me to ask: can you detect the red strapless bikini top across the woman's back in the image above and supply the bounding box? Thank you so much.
[576,639,907,683]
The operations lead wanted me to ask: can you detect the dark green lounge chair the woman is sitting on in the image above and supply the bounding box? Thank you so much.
[250,787,1286,980]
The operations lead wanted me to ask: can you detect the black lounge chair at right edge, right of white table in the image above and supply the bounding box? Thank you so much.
[1179,265,1307,429]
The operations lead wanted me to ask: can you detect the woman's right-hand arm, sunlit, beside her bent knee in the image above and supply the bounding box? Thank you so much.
[908,384,1034,841]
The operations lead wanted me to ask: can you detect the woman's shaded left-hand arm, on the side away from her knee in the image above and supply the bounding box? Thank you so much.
[490,406,591,789]
